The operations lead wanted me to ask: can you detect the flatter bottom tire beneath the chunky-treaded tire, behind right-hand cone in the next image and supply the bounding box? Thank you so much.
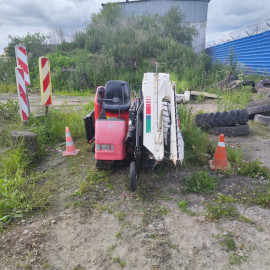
[207,125,249,137]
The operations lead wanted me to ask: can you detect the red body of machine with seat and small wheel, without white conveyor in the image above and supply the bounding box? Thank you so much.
[84,81,142,191]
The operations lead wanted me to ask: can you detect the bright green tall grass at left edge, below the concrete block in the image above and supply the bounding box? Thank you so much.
[0,145,49,223]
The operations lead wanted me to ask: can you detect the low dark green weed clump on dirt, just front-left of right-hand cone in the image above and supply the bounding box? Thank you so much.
[182,170,217,193]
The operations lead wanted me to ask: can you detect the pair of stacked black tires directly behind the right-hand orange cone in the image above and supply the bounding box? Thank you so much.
[195,110,249,137]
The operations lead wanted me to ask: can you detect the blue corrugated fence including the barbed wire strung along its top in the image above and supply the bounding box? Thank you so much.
[206,19,270,75]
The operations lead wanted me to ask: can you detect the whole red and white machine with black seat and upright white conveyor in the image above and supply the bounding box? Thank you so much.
[84,73,186,191]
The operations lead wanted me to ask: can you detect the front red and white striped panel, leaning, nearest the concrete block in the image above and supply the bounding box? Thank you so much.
[15,67,29,122]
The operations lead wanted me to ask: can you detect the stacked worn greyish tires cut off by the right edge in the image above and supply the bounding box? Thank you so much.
[247,97,270,130]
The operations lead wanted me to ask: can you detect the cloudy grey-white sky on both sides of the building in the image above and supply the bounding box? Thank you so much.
[0,0,270,53]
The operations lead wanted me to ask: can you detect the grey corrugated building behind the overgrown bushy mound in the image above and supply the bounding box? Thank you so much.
[102,0,210,52]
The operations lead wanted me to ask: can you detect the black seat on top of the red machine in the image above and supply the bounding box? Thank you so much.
[103,81,130,111]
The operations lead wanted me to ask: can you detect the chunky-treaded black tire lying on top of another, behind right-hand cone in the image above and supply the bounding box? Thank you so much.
[195,110,248,128]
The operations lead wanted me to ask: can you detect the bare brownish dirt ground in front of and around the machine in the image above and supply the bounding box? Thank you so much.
[0,94,270,270]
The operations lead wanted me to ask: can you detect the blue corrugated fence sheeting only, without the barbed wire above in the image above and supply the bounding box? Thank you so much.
[206,31,270,75]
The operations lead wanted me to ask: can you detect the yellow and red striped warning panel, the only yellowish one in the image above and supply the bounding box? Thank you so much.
[39,56,52,106]
